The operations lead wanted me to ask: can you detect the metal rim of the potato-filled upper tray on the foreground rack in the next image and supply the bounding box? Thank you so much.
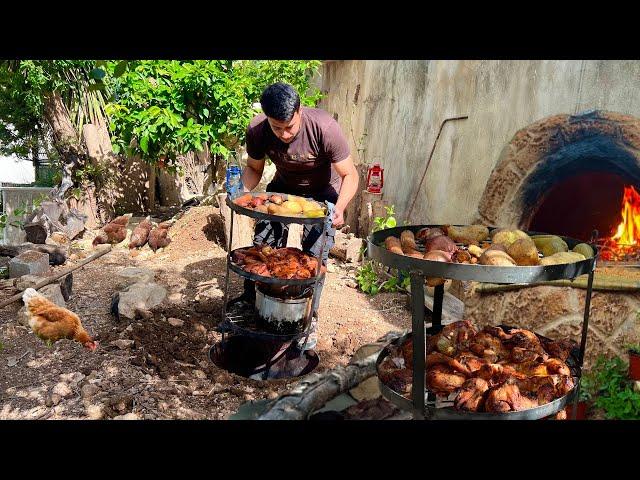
[367,225,598,284]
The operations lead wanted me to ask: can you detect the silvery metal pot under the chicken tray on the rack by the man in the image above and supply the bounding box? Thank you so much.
[256,288,313,335]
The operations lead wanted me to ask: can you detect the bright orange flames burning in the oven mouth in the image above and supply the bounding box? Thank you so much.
[601,186,640,261]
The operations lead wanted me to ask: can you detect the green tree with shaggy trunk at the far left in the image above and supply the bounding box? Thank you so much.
[0,60,108,197]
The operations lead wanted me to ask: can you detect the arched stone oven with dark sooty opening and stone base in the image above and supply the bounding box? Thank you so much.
[462,111,640,367]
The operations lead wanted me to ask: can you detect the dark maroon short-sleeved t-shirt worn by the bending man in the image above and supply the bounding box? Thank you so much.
[247,107,349,203]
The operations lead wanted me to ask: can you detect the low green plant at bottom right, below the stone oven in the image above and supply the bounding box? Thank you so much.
[583,355,640,420]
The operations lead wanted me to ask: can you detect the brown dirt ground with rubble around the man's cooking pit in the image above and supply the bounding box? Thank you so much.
[0,207,411,419]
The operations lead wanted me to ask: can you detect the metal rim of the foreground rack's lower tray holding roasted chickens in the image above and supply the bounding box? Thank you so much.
[376,332,579,420]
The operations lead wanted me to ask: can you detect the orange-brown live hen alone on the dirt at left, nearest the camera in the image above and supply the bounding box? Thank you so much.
[22,288,98,350]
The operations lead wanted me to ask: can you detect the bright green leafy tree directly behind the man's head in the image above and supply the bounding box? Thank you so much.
[105,60,320,171]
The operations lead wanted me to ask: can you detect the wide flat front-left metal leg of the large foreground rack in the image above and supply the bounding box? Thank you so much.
[410,271,425,420]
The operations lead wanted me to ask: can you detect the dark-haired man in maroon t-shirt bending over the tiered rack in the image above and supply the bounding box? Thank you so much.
[232,83,358,349]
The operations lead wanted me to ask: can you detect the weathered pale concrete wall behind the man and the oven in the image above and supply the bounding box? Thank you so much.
[316,60,640,227]
